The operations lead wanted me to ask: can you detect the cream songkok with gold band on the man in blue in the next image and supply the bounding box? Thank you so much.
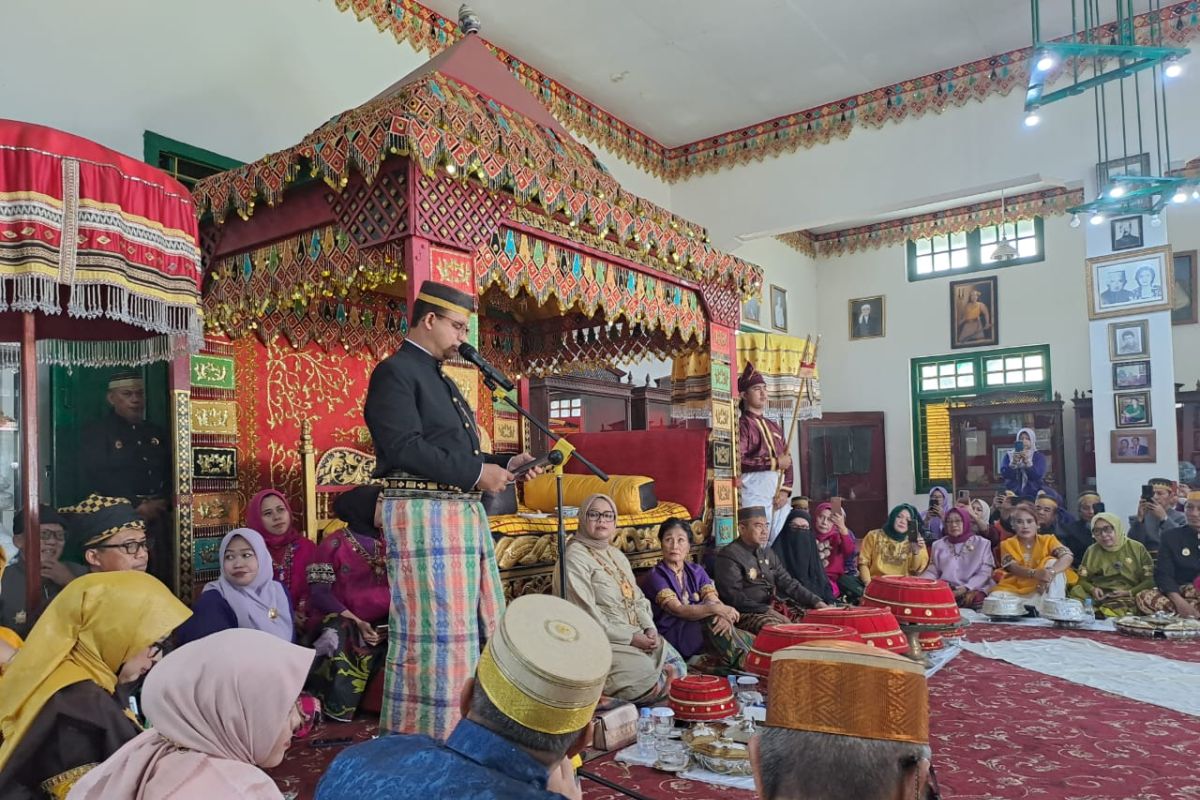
[475,595,612,734]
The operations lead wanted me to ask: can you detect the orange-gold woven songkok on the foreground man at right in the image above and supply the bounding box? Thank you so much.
[767,639,929,745]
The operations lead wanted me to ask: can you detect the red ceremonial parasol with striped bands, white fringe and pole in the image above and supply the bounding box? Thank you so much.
[0,120,203,612]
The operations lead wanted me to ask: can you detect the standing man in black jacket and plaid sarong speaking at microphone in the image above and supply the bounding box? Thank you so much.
[364,281,536,739]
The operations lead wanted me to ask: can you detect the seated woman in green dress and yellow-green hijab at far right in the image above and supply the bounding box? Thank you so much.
[1070,511,1154,616]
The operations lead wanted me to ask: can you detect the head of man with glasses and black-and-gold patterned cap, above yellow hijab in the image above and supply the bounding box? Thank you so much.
[59,494,152,572]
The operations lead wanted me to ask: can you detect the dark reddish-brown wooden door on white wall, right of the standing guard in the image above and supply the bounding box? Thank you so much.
[800,411,888,539]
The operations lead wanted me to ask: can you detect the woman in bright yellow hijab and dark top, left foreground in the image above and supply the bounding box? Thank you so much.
[0,571,191,800]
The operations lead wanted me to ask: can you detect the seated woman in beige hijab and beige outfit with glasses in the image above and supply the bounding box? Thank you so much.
[554,494,688,705]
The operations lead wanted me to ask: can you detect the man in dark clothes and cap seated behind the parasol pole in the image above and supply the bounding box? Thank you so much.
[0,505,88,637]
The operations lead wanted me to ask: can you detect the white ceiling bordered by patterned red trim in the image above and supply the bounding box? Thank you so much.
[424,0,1089,146]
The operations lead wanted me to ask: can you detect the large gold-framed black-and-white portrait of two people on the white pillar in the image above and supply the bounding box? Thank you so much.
[1087,246,1175,319]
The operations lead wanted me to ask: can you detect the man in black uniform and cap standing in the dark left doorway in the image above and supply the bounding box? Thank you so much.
[79,371,174,585]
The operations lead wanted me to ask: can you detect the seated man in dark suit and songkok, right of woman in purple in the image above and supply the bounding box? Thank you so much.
[714,506,826,633]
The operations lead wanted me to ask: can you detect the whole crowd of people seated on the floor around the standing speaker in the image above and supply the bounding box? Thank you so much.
[0,470,1200,800]
